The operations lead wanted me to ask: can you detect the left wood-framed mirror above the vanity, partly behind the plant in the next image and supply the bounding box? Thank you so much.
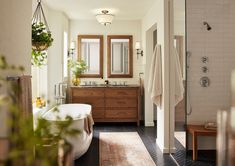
[78,35,104,78]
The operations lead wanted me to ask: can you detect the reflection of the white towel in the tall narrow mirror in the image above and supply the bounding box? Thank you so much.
[174,47,184,106]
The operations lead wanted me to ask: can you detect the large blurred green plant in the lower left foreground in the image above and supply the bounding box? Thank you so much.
[0,56,80,166]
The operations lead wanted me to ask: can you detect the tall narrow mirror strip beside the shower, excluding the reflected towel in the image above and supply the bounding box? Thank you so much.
[172,0,187,165]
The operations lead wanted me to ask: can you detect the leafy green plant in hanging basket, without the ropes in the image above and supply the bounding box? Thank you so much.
[32,22,53,51]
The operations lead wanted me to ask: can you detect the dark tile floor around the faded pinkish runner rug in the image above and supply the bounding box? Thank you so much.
[75,123,214,166]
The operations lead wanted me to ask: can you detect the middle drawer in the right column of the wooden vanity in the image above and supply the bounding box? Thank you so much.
[105,98,137,108]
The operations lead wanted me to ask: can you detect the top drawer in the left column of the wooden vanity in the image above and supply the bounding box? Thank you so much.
[72,88,104,97]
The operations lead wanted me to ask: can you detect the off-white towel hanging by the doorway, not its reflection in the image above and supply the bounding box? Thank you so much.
[148,45,162,107]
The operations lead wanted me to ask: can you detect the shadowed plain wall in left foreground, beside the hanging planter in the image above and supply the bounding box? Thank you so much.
[0,0,32,137]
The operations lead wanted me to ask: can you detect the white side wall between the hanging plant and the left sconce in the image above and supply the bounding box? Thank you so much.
[47,9,69,102]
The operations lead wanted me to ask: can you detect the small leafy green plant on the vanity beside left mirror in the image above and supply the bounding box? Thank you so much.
[68,59,87,78]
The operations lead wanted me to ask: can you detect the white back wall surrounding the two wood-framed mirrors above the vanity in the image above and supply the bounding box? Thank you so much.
[70,19,143,84]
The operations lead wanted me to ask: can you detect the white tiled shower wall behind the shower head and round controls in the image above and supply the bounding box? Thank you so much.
[186,0,235,124]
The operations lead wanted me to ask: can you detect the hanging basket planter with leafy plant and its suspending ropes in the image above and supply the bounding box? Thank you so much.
[32,0,53,51]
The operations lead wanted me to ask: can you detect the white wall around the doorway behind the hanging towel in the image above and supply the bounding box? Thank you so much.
[142,0,164,126]
